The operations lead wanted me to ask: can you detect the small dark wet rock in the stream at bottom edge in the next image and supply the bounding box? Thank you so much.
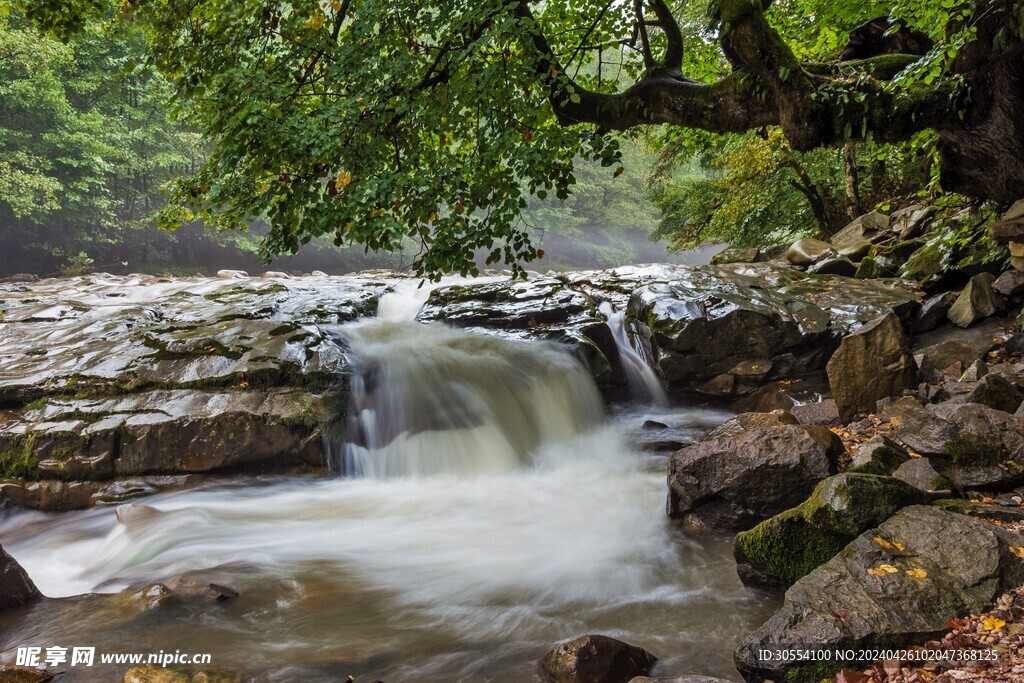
[540,636,657,683]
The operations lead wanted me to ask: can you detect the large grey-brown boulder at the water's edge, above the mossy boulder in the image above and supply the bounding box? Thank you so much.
[669,412,843,530]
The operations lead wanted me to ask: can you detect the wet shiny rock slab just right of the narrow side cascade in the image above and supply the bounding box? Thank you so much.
[629,263,919,389]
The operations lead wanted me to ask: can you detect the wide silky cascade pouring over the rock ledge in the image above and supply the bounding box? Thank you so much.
[332,321,604,478]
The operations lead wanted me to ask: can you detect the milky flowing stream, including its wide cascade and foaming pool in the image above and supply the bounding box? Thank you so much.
[0,280,775,683]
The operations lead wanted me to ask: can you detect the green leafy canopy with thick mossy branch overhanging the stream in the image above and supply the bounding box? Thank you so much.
[16,0,1020,274]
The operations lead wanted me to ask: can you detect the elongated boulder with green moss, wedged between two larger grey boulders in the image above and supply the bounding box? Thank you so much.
[734,473,929,588]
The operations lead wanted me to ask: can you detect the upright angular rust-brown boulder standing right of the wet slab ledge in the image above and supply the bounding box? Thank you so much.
[826,313,918,420]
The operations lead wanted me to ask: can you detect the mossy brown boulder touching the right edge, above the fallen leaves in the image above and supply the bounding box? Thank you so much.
[896,403,1024,490]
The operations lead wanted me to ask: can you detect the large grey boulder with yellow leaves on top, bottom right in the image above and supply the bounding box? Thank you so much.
[735,506,1024,681]
